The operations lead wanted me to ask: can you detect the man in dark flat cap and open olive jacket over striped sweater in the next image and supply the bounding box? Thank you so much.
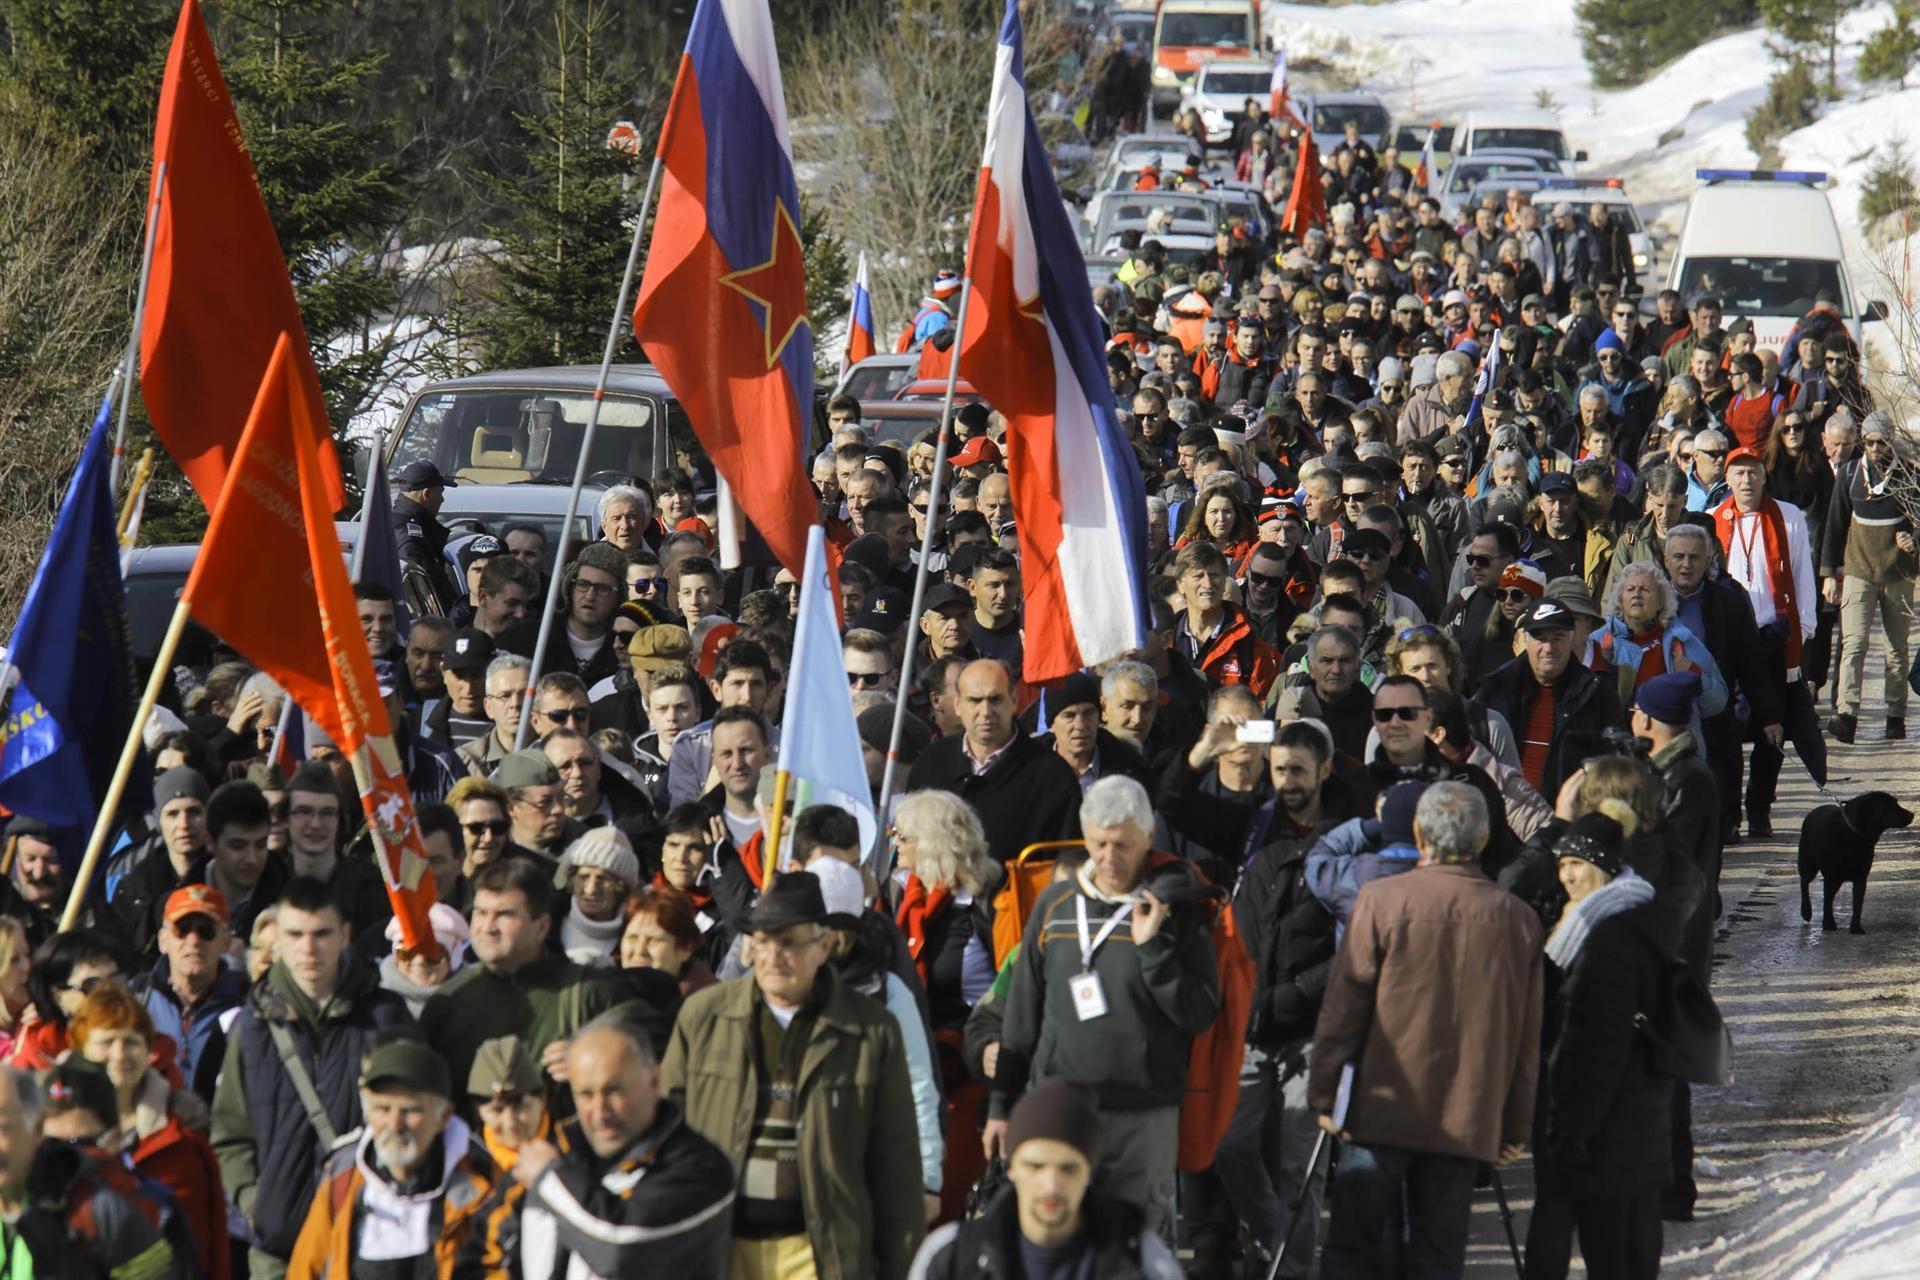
[660,871,925,1280]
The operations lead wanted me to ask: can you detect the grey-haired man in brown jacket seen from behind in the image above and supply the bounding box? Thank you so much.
[1308,783,1542,1280]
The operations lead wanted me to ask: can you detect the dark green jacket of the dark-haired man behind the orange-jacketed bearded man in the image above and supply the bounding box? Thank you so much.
[420,954,628,1094]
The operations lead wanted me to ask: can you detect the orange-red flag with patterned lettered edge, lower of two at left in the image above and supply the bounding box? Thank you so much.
[180,334,438,954]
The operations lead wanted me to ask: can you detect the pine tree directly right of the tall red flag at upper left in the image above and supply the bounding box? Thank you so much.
[213,0,407,426]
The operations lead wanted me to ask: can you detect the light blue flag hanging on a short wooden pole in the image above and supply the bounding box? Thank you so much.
[780,524,877,867]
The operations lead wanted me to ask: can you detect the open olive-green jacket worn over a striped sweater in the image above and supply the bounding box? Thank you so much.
[660,967,925,1280]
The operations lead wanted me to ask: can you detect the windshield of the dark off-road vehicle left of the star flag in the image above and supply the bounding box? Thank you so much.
[388,388,693,484]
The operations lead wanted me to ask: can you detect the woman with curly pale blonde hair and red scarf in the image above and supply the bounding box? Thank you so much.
[889,791,1000,1031]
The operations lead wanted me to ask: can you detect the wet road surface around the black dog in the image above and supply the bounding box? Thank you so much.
[1469,660,1920,1278]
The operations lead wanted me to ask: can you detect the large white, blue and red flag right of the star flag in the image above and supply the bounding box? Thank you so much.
[960,0,1146,681]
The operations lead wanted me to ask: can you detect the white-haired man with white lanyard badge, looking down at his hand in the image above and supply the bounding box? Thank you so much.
[985,777,1221,1230]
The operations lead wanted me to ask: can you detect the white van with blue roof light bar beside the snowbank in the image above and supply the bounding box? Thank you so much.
[1667,169,1880,349]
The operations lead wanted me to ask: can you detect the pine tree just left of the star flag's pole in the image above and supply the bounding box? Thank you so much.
[480,0,653,367]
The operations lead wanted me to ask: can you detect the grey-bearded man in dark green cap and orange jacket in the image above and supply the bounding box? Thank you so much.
[286,1031,501,1280]
